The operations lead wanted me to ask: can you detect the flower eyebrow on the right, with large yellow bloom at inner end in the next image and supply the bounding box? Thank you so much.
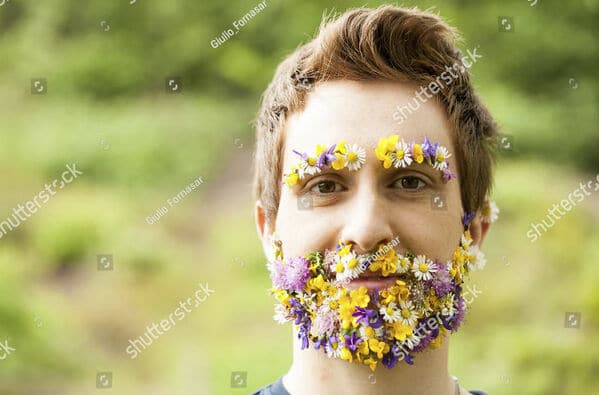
[374,134,455,183]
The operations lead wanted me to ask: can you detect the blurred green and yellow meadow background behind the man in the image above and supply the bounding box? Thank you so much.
[0,0,599,395]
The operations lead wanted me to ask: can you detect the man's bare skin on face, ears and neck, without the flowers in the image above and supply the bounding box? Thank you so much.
[255,81,489,395]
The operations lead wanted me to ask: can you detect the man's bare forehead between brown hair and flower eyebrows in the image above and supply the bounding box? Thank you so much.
[284,81,453,160]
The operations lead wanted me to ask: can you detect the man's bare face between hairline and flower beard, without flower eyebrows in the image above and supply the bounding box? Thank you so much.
[274,81,463,261]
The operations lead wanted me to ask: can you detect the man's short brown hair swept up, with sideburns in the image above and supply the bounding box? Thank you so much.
[254,6,497,223]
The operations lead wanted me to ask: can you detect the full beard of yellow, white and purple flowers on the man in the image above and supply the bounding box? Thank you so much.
[267,229,485,371]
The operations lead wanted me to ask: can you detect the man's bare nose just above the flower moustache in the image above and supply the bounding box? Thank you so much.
[341,188,395,254]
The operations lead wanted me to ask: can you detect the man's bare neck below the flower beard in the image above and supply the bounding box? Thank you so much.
[283,329,455,395]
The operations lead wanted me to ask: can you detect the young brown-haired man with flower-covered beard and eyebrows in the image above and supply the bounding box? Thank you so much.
[254,6,497,395]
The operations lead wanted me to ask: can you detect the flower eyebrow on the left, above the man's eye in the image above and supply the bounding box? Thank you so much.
[283,141,366,187]
